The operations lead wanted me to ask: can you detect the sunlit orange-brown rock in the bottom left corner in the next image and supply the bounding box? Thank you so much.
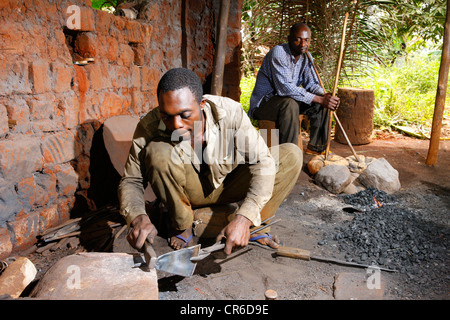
[0,257,37,299]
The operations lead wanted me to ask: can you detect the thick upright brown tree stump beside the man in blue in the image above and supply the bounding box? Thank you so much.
[334,88,375,145]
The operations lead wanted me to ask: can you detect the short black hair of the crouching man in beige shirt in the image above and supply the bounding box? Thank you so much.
[156,68,203,104]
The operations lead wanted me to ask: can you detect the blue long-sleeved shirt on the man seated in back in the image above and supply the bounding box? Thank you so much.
[248,43,324,118]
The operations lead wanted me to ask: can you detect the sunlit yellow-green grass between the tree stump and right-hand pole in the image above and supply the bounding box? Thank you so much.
[351,53,450,127]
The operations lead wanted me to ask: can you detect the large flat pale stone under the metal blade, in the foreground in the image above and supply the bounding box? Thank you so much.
[30,252,158,300]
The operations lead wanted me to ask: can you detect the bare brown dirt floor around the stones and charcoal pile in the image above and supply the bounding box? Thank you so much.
[20,132,450,300]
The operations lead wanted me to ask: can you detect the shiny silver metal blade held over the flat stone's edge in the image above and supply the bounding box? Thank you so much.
[155,244,200,277]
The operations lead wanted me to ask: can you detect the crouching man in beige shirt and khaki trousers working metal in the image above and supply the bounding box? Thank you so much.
[119,68,303,254]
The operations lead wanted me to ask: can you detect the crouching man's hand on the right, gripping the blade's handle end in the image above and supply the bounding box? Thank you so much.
[217,214,252,254]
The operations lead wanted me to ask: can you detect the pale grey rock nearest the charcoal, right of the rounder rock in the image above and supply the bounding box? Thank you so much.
[358,158,400,193]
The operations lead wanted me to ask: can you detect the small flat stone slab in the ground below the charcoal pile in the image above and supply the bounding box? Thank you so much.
[333,270,385,300]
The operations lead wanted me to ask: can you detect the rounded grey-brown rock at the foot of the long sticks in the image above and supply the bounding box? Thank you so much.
[315,164,352,194]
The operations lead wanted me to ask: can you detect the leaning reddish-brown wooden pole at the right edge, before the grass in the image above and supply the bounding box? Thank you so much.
[426,0,450,166]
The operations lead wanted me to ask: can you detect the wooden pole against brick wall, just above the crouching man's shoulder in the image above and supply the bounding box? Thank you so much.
[211,0,230,95]
